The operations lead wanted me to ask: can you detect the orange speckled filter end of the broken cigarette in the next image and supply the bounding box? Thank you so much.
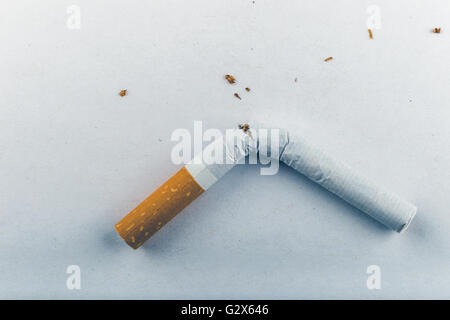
[116,167,205,249]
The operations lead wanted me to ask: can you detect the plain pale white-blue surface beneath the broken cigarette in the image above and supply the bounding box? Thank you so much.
[0,0,450,299]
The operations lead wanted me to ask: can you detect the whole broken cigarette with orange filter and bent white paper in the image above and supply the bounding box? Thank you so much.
[116,124,417,249]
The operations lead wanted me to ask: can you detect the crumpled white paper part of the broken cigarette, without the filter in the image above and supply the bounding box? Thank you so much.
[186,123,417,232]
